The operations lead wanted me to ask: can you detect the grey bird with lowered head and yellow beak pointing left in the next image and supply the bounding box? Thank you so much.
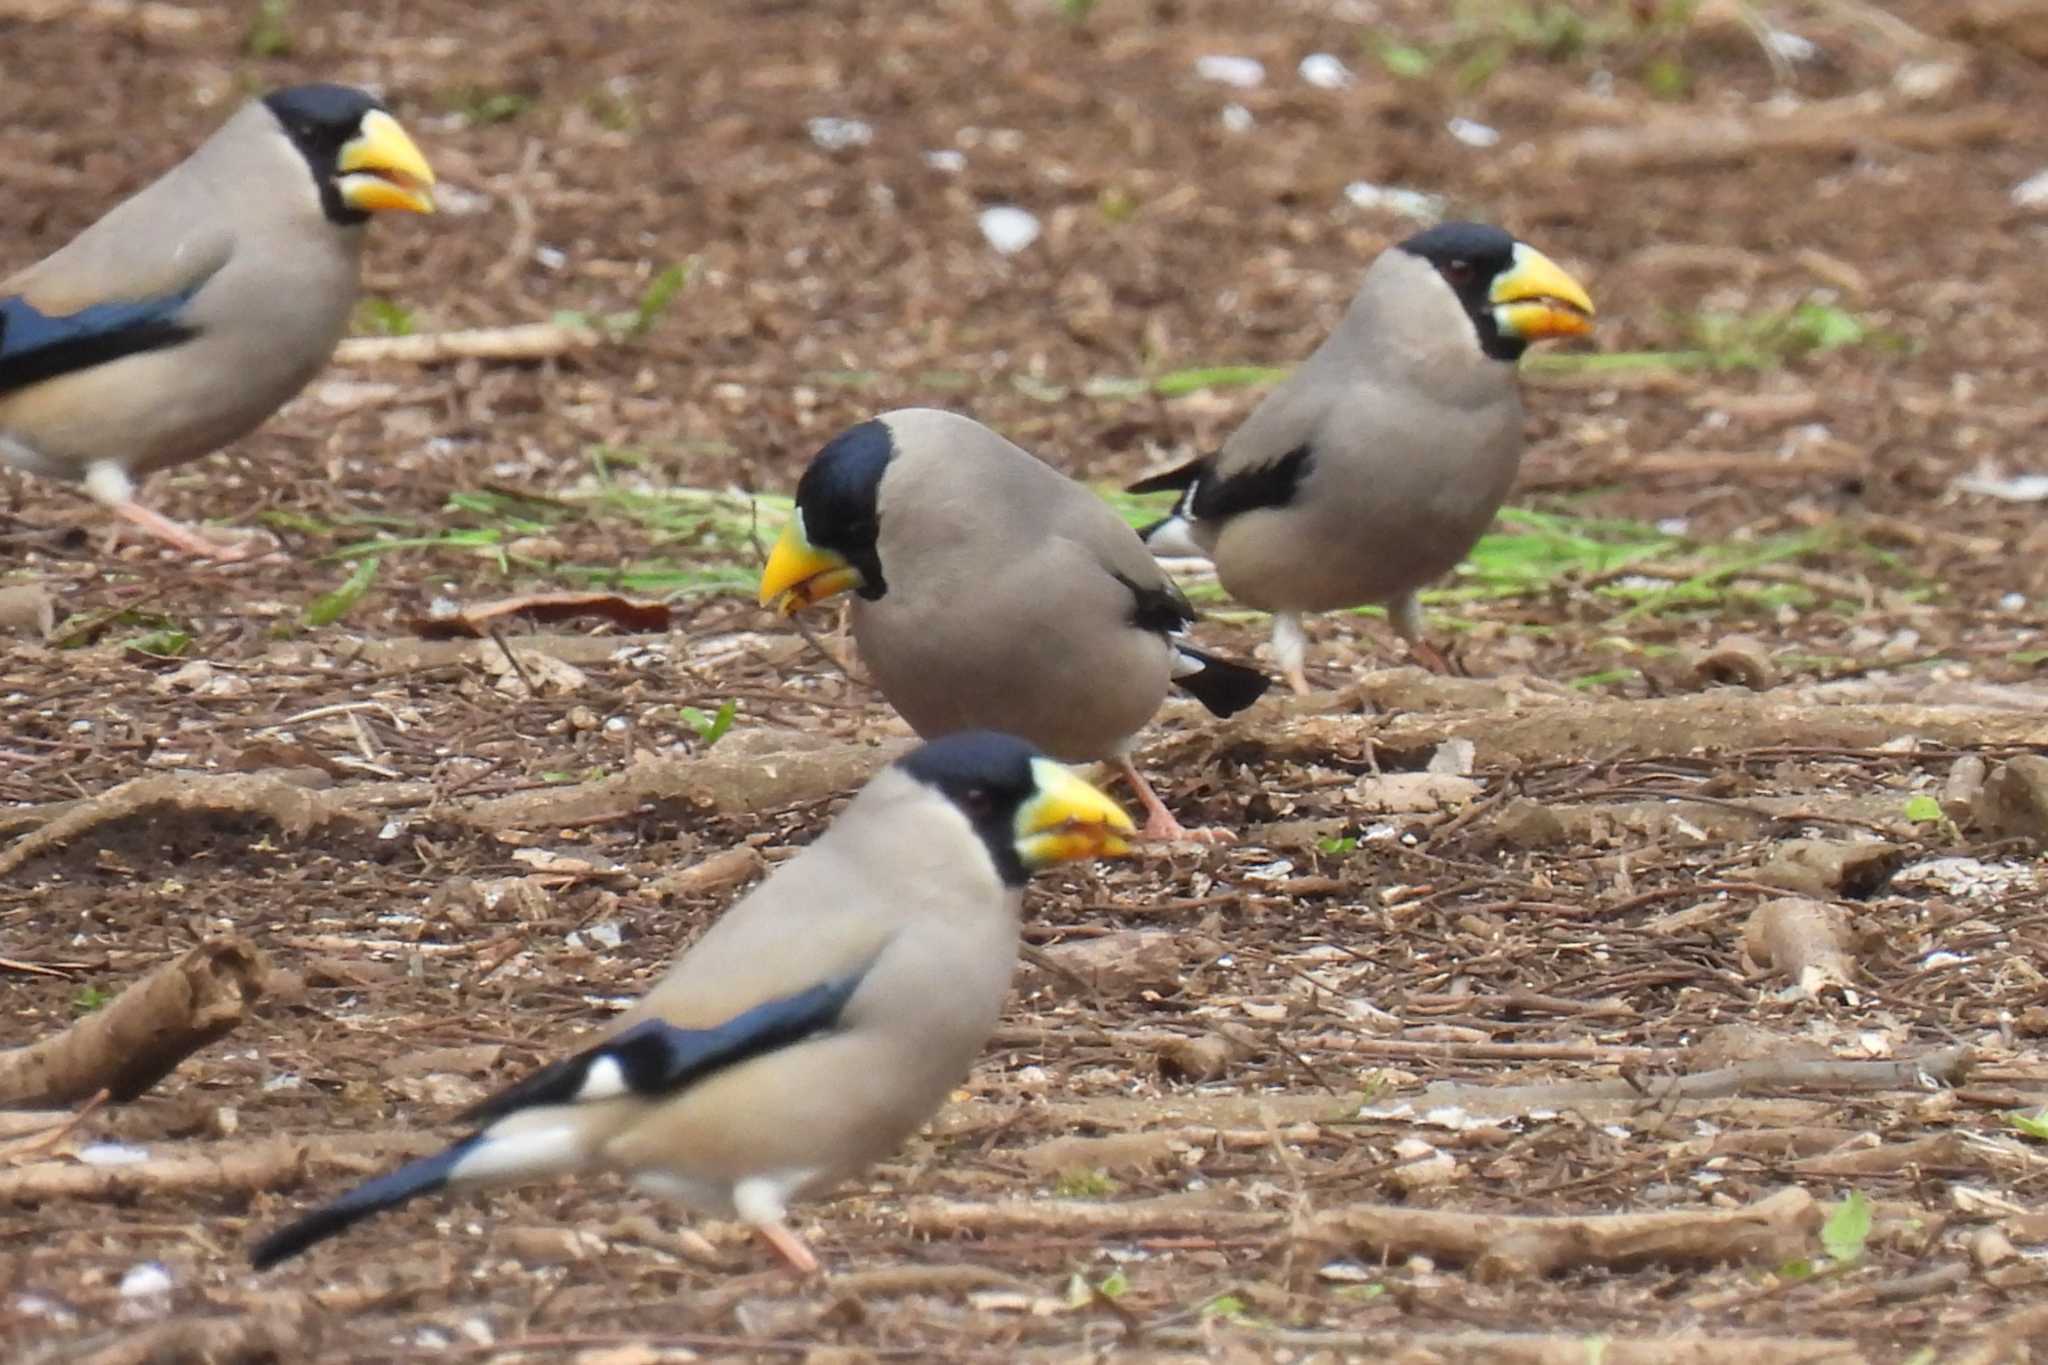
[760,407,1270,841]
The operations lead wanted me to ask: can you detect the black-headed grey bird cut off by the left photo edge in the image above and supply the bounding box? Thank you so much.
[0,84,434,559]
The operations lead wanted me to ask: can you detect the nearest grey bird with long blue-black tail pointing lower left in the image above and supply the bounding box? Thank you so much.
[250,731,1133,1275]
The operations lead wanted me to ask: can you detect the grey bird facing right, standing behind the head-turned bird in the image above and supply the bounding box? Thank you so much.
[1128,223,1593,694]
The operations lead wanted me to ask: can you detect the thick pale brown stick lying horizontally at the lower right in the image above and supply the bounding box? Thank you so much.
[1294,1189,1823,1281]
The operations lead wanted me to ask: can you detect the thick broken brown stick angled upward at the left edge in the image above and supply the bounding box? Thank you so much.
[0,937,270,1105]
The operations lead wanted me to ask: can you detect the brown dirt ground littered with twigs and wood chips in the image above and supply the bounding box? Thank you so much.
[0,0,2048,1365]
